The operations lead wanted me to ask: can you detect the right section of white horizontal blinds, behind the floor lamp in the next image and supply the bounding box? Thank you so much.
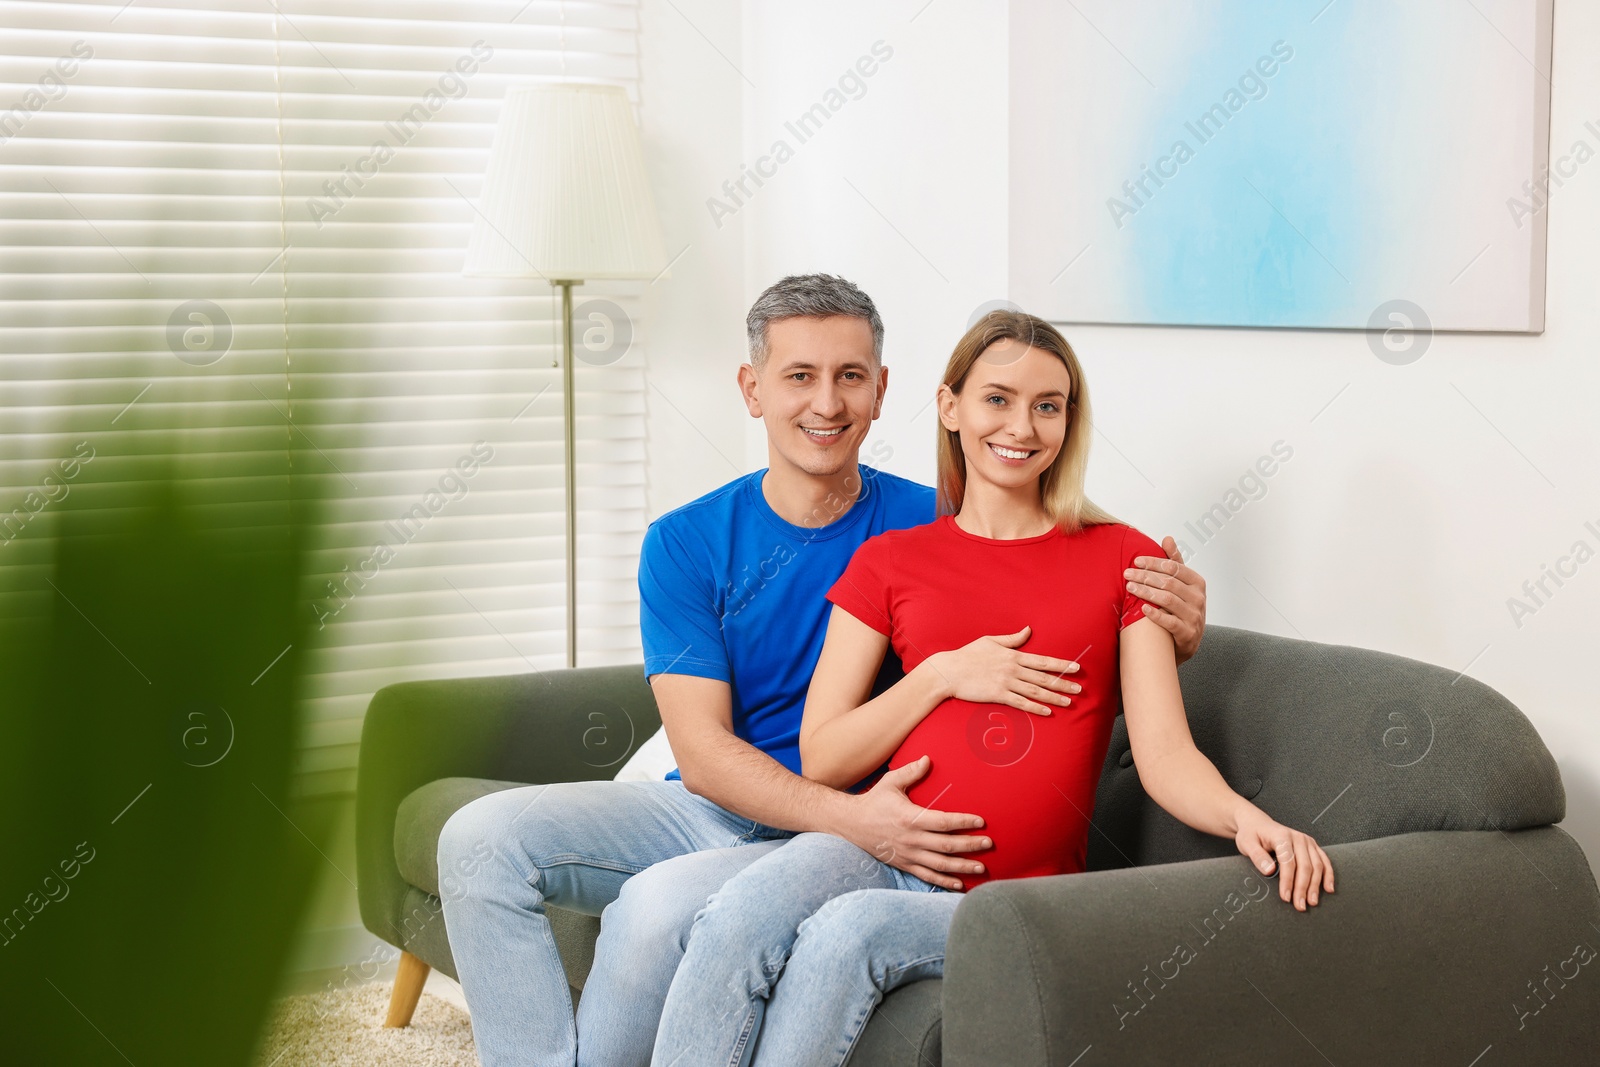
[280,0,645,789]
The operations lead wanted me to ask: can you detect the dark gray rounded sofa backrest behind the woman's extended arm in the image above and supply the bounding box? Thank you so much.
[1088,625,1566,870]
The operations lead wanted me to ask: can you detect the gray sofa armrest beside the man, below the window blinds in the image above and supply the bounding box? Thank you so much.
[355,664,661,937]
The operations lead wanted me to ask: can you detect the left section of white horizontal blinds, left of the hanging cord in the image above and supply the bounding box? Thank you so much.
[0,3,291,591]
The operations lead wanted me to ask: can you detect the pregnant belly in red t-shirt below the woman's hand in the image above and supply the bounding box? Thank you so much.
[890,701,1110,889]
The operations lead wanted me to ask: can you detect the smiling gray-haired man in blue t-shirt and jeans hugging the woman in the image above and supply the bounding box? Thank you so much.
[438,275,1205,1067]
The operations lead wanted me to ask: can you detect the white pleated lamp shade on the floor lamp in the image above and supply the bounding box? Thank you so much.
[462,82,667,282]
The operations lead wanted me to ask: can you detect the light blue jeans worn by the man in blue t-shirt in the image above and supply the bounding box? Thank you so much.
[438,781,790,1067]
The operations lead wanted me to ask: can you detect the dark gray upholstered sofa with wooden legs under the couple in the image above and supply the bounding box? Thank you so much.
[357,627,1600,1067]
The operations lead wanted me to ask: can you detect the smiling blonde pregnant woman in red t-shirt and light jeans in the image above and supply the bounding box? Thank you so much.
[653,310,1334,1067]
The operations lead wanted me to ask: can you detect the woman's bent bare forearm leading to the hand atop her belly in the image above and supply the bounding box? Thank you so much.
[800,657,949,789]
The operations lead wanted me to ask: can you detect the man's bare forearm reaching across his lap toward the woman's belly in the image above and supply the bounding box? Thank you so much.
[678,729,851,833]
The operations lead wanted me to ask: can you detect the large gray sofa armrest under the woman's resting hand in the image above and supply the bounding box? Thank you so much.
[942,827,1600,1067]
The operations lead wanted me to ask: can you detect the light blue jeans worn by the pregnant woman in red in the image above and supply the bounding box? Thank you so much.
[651,833,962,1067]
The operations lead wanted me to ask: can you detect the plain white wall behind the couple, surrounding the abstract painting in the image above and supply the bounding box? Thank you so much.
[645,0,1600,867]
